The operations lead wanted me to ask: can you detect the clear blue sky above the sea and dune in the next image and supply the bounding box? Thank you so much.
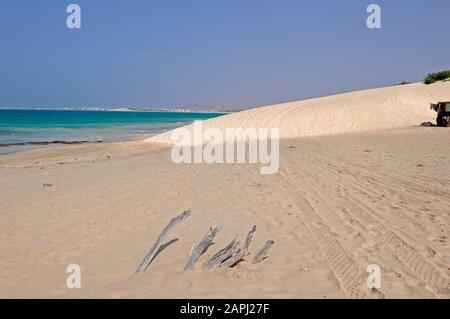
[0,0,450,107]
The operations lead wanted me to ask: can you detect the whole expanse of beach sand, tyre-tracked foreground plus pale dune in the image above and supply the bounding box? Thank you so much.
[0,82,450,298]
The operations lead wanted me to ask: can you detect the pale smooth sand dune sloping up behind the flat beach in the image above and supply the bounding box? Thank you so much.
[146,82,450,144]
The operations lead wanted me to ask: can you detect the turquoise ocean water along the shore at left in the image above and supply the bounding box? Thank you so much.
[0,110,223,149]
